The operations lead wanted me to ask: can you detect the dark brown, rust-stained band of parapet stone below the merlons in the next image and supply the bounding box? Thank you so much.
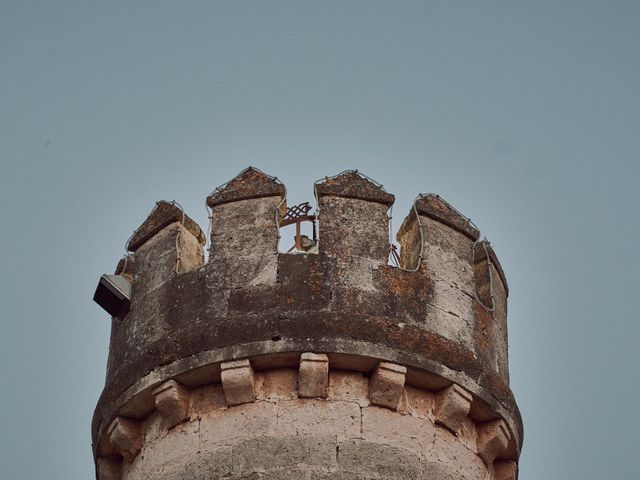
[96,234,520,452]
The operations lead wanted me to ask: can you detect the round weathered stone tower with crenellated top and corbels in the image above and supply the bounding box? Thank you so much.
[92,168,522,480]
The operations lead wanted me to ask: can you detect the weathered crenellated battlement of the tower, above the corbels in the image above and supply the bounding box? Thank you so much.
[93,167,522,478]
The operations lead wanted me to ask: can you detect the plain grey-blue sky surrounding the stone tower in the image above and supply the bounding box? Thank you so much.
[0,0,640,480]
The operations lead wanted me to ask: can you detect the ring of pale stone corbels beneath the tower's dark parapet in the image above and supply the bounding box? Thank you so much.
[97,352,517,480]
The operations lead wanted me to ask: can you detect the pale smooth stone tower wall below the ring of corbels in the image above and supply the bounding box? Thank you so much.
[123,376,504,480]
